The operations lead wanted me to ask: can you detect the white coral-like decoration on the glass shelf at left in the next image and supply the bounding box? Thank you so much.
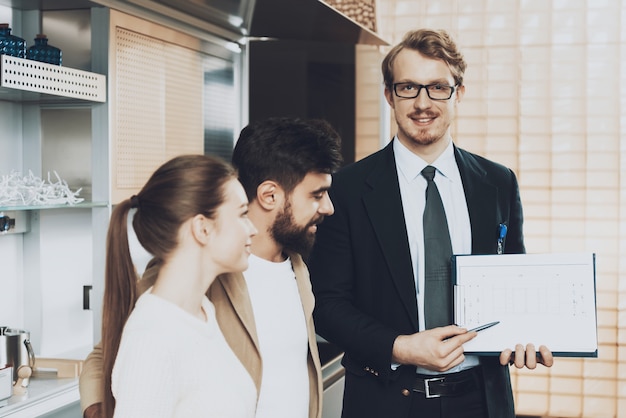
[0,171,85,206]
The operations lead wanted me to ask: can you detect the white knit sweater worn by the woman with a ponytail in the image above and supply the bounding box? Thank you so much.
[111,291,257,418]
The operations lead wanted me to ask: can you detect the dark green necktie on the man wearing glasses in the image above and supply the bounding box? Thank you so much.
[422,166,452,329]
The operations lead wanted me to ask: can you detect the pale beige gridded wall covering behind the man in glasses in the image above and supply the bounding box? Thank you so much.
[357,0,626,418]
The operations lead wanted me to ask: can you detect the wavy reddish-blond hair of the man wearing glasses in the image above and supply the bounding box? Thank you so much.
[382,29,467,90]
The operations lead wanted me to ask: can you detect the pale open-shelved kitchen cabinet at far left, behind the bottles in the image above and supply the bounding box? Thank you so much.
[0,0,110,356]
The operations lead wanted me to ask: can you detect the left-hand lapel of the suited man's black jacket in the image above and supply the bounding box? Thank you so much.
[363,141,418,330]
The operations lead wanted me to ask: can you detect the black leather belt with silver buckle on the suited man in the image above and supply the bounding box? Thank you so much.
[413,366,480,398]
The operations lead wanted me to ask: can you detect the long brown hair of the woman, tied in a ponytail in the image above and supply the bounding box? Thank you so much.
[102,155,236,417]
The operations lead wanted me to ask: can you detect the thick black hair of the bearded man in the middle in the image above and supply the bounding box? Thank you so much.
[232,117,343,200]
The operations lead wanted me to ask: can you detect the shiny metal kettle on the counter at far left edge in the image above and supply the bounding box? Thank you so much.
[0,326,35,387]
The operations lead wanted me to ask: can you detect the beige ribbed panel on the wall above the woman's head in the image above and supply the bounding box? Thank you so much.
[109,11,204,204]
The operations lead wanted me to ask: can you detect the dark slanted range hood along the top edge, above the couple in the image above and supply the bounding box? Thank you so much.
[113,0,387,45]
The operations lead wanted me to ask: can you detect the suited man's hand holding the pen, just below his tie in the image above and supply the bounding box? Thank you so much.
[392,325,478,372]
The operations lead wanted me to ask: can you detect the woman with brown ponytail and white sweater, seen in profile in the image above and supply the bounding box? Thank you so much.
[102,155,257,418]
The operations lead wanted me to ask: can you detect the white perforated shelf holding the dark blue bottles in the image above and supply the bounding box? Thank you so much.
[0,55,106,103]
